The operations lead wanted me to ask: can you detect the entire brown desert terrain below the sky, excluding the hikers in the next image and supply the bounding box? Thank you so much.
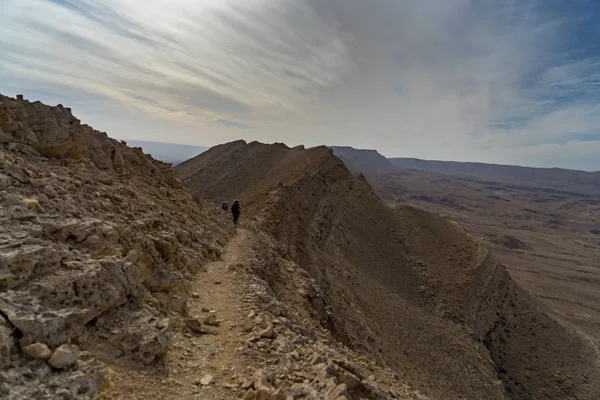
[0,96,600,400]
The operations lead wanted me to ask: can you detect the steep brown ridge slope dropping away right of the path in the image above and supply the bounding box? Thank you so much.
[179,142,598,399]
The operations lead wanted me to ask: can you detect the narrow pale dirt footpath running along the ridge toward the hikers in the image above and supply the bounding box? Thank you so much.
[100,228,252,400]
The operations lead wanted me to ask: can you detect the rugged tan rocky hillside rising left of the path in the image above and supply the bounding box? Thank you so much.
[0,96,229,399]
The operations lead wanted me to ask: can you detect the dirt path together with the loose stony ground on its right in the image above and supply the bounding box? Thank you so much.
[100,228,426,400]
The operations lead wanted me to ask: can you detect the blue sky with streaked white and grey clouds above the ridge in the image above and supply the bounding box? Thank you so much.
[0,0,600,170]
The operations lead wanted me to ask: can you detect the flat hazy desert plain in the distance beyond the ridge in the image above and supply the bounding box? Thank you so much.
[334,147,600,349]
